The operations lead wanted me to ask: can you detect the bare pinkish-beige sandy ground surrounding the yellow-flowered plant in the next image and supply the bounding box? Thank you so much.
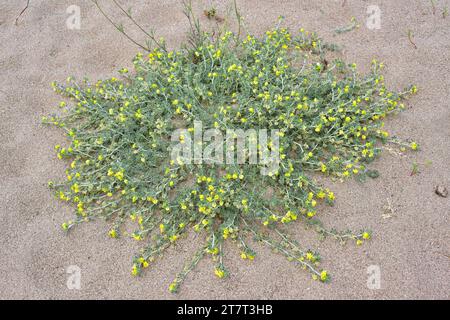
[0,0,450,299]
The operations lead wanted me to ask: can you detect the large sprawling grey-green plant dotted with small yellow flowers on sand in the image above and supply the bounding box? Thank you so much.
[43,7,417,292]
